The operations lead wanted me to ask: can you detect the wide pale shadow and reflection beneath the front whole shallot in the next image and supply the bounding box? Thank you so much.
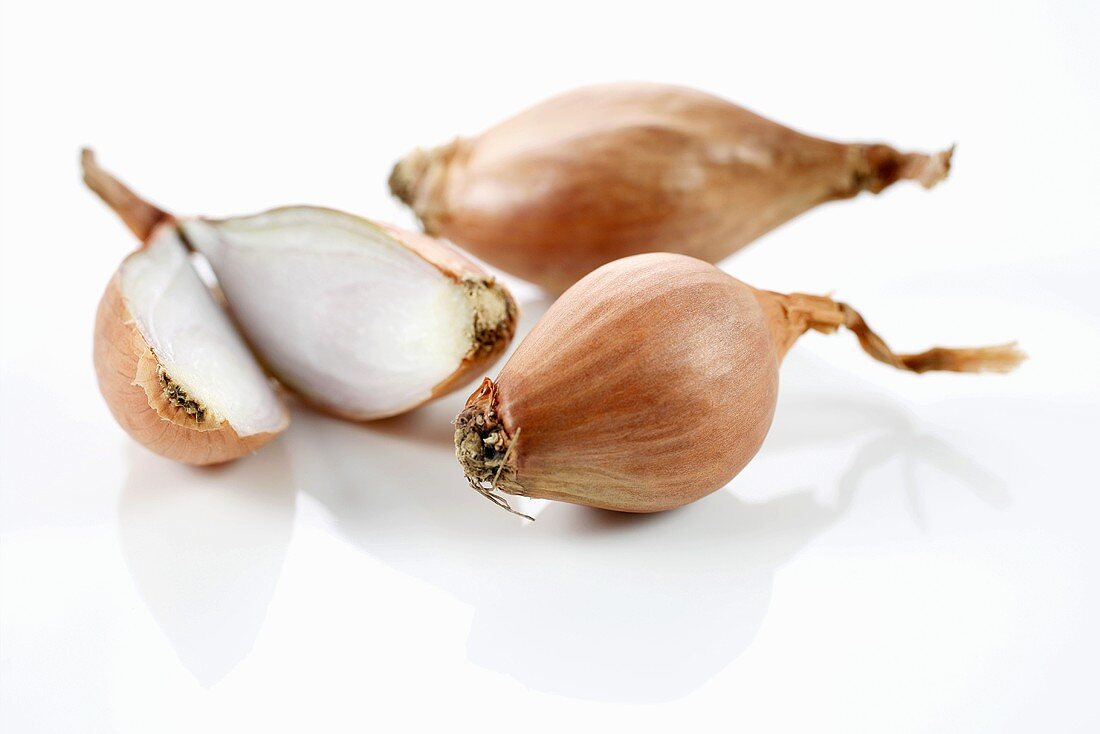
[279,376,1007,702]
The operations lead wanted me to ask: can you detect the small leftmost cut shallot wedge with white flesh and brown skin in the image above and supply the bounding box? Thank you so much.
[94,224,287,464]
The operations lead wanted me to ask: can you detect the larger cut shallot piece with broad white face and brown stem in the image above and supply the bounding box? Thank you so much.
[83,151,517,420]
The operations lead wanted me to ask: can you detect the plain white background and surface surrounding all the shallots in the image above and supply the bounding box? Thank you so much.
[0,0,1100,733]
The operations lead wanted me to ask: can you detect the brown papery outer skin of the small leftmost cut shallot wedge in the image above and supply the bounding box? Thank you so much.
[94,269,285,465]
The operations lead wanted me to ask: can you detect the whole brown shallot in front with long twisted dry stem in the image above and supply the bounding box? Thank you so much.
[455,253,1023,513]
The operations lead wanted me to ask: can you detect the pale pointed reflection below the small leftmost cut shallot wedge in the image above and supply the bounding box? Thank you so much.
[119,439,295,687]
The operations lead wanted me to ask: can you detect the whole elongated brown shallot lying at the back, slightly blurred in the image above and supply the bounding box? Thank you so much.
[389,84,950,293]
